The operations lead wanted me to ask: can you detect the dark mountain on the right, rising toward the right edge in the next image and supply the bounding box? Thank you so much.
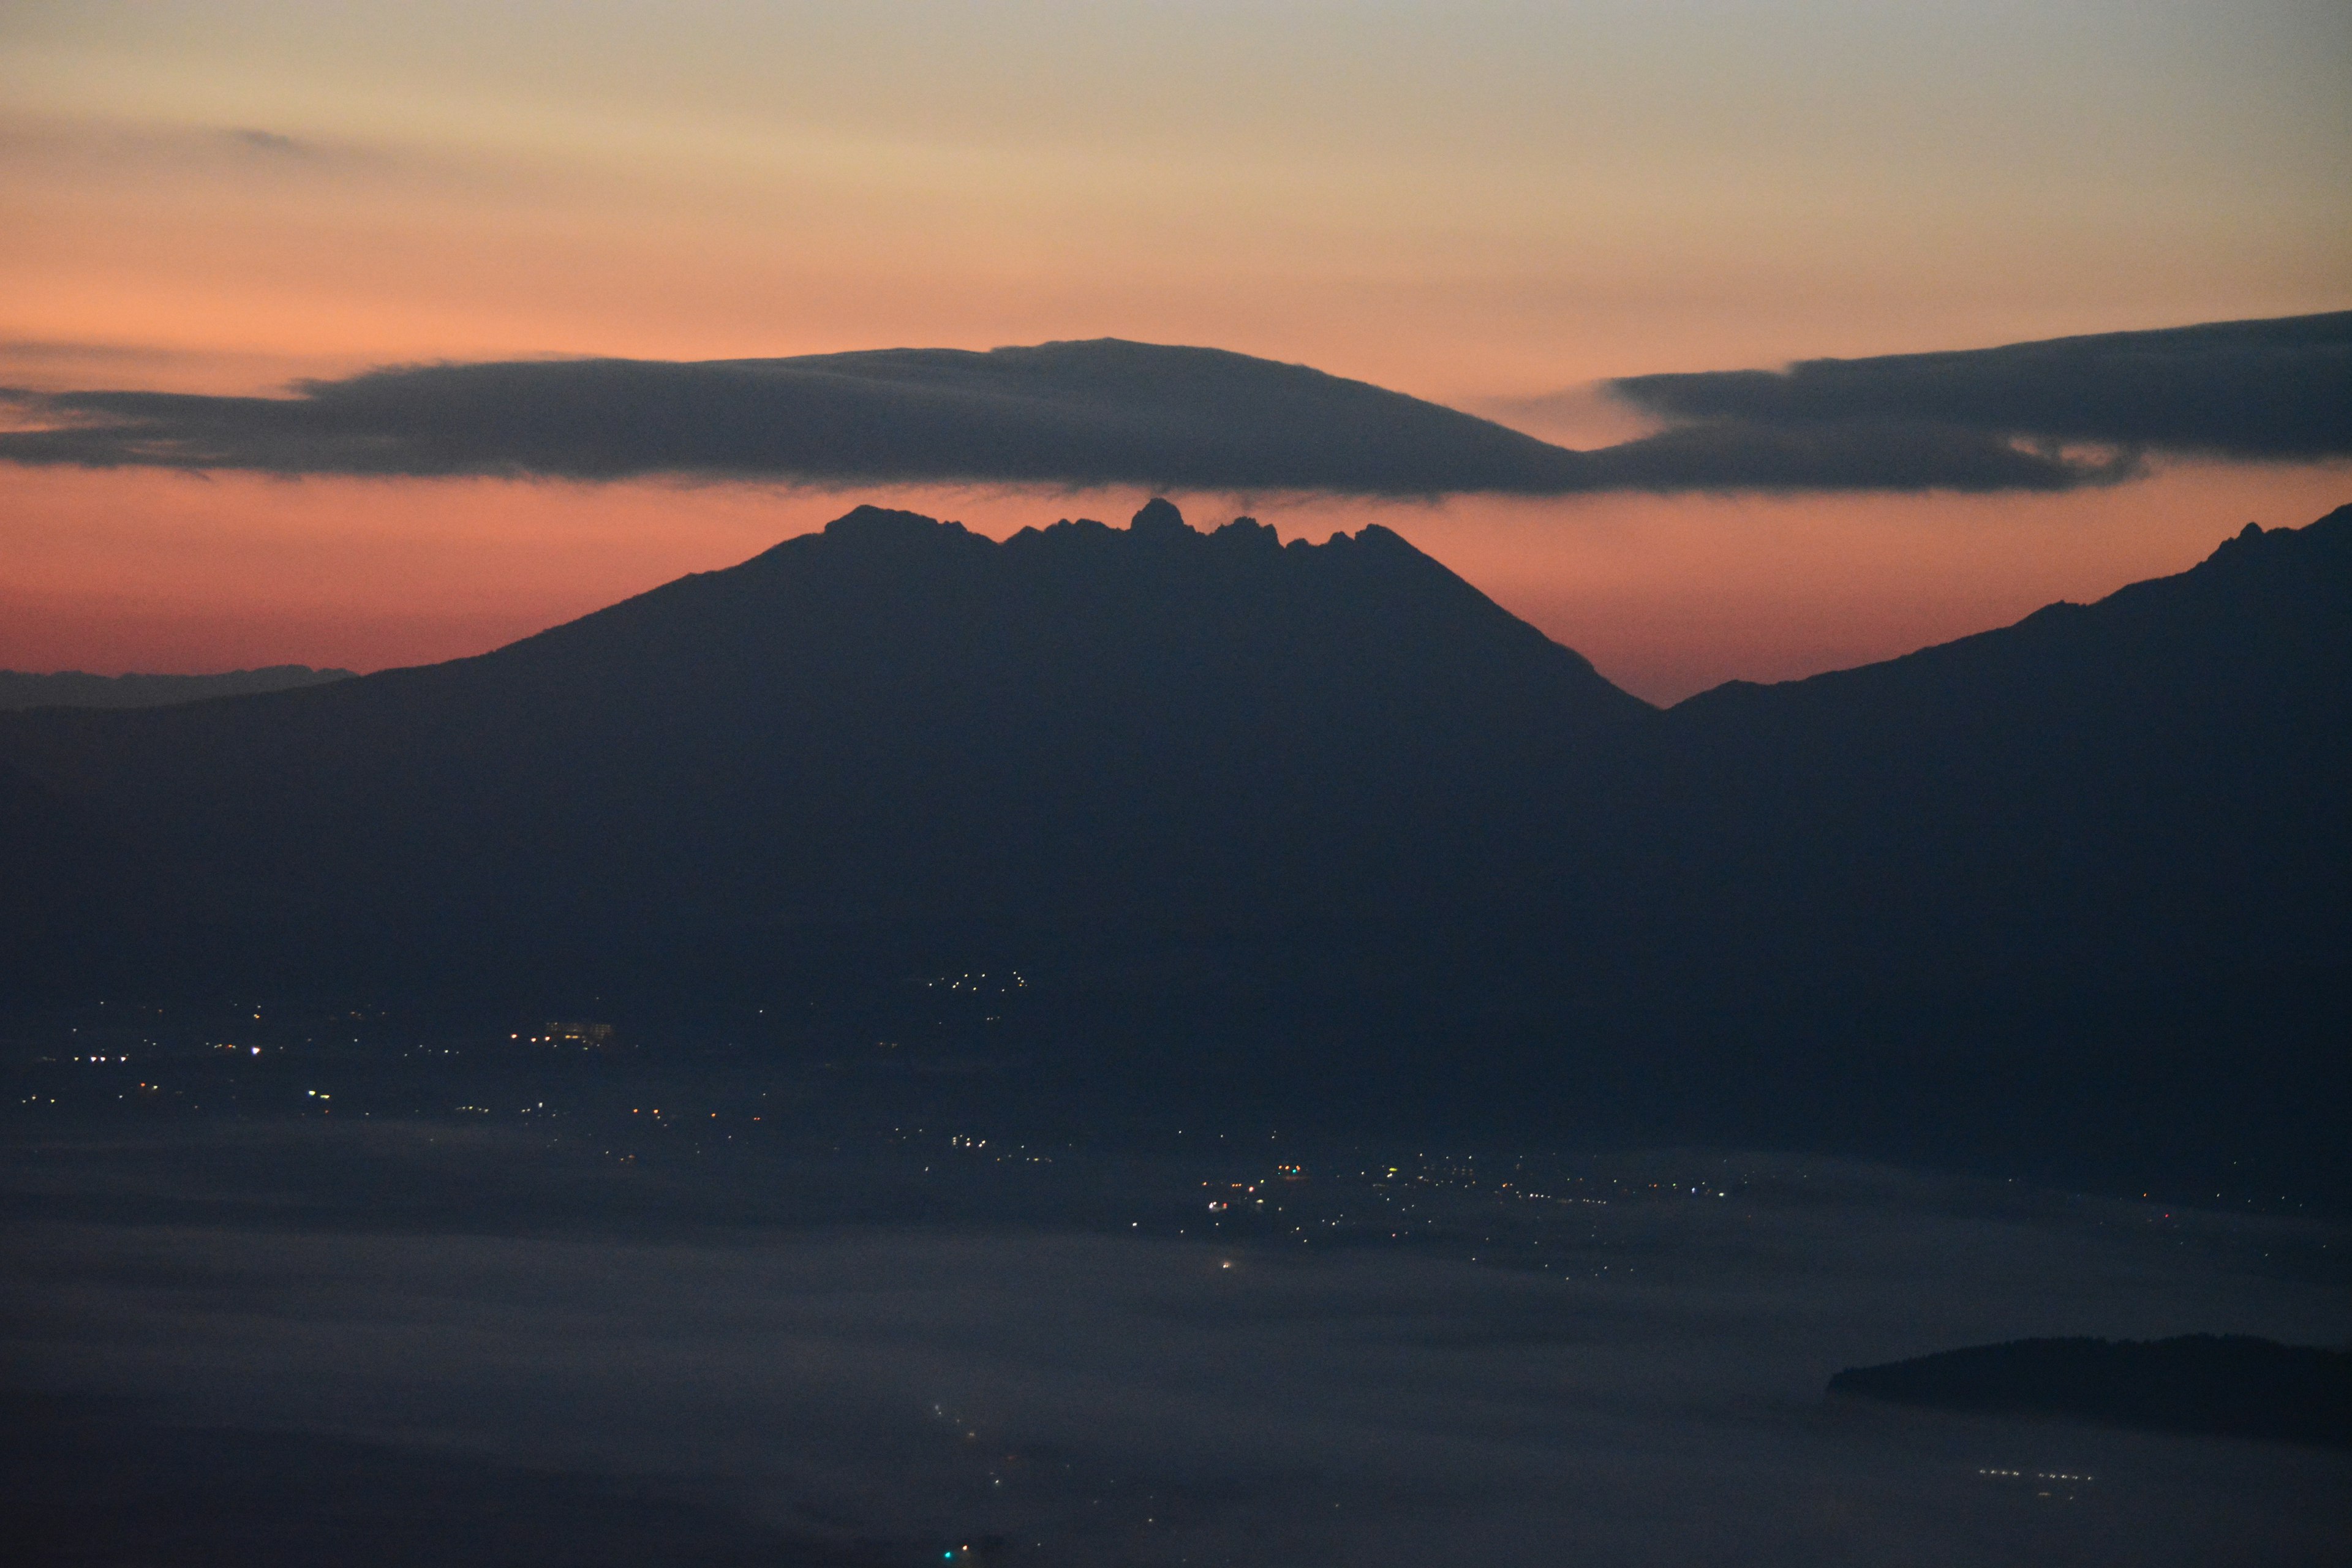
[1642,508,2352,1180]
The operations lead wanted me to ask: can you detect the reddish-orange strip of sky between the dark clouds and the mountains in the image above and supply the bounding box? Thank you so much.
[0,453,2352,703]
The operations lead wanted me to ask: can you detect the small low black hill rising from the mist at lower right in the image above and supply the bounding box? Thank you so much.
[1830,1333,2352,1448]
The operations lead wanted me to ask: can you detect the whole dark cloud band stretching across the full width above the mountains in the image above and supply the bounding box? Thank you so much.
[0,315,2352,496]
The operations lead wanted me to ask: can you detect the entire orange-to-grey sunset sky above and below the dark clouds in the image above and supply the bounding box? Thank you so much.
[0,0,2352,701]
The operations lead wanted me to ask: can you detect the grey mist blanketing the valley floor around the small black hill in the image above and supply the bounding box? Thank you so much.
[0,1121,2352,1566]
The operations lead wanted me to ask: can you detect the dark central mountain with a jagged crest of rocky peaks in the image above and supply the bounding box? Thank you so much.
[5,503,1654,968]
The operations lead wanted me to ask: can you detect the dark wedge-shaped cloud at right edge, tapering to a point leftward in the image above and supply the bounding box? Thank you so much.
[1611,311,2352,465]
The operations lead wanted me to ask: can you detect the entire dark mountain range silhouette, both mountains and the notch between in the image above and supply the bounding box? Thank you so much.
[0,501,2352,1192]
